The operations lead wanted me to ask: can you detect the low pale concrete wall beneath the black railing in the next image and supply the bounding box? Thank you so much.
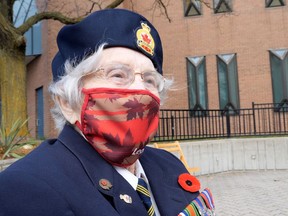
[180,137,288,175]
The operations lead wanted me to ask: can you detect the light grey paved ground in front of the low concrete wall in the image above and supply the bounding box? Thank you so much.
[198,170,288,216]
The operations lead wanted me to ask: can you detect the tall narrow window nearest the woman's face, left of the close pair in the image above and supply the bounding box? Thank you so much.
[187,56,207,115]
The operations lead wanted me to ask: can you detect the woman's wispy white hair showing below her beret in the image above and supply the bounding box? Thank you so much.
[49,44,173,131]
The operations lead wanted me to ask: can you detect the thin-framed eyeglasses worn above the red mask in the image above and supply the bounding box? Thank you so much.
[96,64,165,92]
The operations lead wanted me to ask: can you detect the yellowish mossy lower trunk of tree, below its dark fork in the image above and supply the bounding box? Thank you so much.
[0,50,28,135]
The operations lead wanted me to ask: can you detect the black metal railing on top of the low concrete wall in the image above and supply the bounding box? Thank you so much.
[153,103,288,141]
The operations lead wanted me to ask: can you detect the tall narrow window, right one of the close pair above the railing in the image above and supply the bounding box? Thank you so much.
[217,54,240,114]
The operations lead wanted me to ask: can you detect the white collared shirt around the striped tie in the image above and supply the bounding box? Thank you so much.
[114,160,160,216]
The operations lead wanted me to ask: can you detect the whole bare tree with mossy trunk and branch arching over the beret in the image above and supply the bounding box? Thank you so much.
[0,0,169,133]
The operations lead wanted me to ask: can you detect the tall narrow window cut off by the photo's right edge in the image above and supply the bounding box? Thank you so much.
[270,49,288,106]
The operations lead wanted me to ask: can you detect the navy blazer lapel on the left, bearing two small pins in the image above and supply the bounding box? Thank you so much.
[58,125,147,216]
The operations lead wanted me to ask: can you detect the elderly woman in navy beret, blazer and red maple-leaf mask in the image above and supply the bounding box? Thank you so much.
[0,9,214,216]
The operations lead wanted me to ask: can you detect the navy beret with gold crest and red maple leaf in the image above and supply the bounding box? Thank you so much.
[52,9,163,81]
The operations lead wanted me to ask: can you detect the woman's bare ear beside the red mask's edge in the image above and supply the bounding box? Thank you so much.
[56,97,80,124]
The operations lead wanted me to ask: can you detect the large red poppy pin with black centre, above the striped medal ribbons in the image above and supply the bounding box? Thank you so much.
[178,173,200,192]
